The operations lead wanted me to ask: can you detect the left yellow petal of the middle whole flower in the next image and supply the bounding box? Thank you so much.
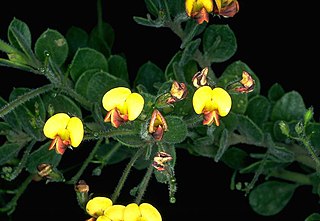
[102,87,131,111]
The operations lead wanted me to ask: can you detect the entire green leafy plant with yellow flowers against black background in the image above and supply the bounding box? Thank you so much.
[0,0,320,220]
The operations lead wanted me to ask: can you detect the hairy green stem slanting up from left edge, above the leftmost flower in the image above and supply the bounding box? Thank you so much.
[0,84,53,117]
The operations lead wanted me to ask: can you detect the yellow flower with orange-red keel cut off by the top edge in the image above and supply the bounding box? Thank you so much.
[185,0,214,24]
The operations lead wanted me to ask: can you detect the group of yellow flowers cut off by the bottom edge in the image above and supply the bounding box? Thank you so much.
[86,196,162,221]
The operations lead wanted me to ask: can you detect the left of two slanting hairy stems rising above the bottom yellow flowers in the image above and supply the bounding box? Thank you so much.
[111,147,144,203]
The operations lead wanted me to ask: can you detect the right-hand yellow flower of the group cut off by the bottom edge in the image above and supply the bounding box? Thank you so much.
[123,203,162,221]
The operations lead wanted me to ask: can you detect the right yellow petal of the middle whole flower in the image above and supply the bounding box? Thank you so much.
[126,93,144,121]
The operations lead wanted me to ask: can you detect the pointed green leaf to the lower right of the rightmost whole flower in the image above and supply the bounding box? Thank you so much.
[238,114,263,144]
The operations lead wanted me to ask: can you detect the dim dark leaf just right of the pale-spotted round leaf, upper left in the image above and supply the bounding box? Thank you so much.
[66,26,89,57]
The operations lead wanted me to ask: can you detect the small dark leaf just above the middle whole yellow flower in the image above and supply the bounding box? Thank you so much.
[108,55,129,82]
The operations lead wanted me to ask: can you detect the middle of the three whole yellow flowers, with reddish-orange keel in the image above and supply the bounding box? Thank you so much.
[102,87,144,127]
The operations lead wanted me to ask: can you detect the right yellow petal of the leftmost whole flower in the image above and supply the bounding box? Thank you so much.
[67,117,84,147]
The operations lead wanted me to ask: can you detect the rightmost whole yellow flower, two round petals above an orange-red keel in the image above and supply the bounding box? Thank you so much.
[192,86,232,126]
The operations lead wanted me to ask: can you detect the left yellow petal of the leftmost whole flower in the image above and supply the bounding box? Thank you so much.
[43,113,70,139]
